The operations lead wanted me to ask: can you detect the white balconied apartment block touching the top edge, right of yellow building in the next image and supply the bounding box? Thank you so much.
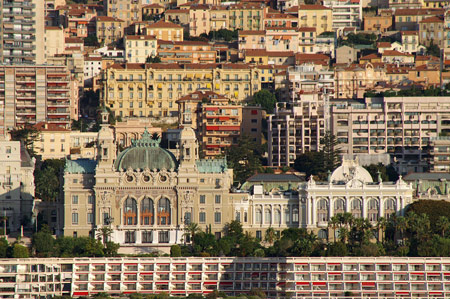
[323,0,362,30]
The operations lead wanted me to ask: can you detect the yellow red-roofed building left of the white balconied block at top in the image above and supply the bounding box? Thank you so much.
[298,4,333,35]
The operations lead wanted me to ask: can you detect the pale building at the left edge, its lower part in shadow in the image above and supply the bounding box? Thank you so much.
[0,134,35,232]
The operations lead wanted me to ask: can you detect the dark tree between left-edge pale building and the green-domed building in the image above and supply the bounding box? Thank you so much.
[34,159,66,201]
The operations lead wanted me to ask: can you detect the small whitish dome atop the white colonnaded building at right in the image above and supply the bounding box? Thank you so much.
[330,158,373,183]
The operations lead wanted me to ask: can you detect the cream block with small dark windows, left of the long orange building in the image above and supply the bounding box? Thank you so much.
[124,35,158,63]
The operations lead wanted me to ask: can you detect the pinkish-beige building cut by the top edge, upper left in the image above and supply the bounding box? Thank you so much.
[103,0,142,27]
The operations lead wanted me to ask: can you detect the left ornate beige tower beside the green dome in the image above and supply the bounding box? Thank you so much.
[97,107,116,168]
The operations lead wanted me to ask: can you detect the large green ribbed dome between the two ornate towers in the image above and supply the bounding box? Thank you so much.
[115,129,177,171]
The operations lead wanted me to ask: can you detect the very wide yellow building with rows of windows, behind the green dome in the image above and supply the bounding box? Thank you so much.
[102,63,261,118]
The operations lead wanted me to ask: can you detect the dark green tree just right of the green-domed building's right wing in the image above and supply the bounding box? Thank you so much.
[225,135,263,184]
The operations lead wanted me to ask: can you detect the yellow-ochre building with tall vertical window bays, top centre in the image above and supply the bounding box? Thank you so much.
[229,2,264,30]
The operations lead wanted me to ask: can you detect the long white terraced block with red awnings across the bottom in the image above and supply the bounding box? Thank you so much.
[0,257,450,299]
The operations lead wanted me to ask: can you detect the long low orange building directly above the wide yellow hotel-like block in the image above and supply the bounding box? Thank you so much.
[157,41,217,63]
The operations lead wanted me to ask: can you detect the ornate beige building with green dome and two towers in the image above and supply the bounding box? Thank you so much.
[64,112,239,253]
